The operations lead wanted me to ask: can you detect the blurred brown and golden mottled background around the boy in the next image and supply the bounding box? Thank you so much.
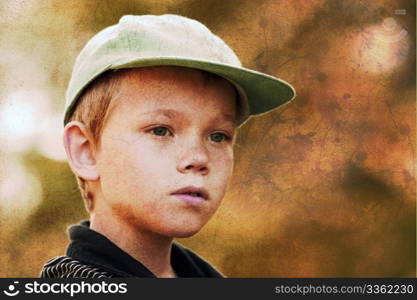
[0,0,416,277]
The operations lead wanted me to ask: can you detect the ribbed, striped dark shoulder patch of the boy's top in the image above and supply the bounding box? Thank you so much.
[40,256,114,278]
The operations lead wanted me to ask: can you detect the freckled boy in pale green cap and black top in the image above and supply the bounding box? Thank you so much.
[41,15,295,278]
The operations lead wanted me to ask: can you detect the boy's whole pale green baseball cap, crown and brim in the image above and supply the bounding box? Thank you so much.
[64,14,295,125]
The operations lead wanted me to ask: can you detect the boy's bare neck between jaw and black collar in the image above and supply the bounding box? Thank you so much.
[90,207,176,278]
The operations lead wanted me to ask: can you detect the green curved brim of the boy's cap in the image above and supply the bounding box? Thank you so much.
[64,57,296,123]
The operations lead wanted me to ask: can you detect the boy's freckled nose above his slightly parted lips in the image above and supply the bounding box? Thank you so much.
[177,138,209,175]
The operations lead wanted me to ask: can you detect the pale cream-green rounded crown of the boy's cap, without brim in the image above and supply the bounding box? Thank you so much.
[65,14,241,120]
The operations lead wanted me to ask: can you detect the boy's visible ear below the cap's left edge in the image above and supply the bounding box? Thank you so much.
[64,121,99,181]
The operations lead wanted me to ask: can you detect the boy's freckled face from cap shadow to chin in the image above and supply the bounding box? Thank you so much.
[93,67,236,237]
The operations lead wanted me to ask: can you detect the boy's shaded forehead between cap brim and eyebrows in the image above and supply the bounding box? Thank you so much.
[109,67,236,121]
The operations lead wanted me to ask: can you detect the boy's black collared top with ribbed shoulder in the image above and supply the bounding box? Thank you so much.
[41,221,223,278]
